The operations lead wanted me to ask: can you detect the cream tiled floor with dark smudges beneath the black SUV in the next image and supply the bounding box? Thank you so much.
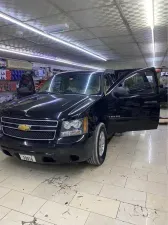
[0,125,168,225]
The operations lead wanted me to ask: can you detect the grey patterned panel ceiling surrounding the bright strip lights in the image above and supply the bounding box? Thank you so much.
[0,0,168,69]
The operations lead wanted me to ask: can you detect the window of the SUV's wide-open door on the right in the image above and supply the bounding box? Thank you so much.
[114,70,156,96]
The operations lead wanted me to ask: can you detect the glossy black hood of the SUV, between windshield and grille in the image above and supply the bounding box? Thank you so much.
[2,94,100,119]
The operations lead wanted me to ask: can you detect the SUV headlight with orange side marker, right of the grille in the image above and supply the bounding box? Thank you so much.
[60,117,88,137]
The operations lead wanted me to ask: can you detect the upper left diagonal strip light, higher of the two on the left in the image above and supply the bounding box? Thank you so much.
[0,12,107,61]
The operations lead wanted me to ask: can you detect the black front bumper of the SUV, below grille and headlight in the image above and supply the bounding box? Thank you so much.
[0,135,93,164]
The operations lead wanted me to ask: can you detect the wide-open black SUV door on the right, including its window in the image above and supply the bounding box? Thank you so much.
[106,68,160,133]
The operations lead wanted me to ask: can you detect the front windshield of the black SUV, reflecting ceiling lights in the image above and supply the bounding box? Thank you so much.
[39,72,101,95]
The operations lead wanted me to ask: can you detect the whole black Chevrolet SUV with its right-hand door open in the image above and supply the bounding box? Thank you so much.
[0,68,160,165]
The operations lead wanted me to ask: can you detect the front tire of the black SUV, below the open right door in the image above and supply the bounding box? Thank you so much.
[87,123,107,166]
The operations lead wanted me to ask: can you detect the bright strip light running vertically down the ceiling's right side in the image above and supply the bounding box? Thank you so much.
[145,0,155,67]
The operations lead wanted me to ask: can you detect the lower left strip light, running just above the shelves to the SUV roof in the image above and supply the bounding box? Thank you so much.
[0,48,102,70]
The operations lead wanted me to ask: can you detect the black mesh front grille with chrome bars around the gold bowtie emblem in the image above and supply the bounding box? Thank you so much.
[1,117,58,140]
